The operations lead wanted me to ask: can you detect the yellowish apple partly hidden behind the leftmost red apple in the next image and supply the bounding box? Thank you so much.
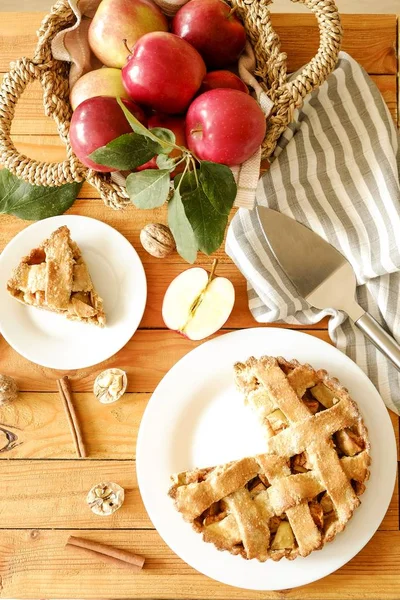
[69,67,129,110]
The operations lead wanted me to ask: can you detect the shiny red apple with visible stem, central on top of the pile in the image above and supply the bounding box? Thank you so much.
[122,31,206,114]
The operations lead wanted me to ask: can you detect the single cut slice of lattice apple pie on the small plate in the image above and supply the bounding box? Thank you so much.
[7,226,106,327]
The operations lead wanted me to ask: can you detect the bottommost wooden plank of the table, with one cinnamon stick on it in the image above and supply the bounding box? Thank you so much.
[0,529,400,600]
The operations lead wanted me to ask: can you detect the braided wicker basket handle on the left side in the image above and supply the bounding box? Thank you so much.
[0,58,87,186]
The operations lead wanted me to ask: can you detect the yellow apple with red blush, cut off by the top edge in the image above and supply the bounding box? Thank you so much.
[88,0,168,69]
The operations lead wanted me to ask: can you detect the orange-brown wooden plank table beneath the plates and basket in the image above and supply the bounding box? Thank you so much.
[0,13,400,600]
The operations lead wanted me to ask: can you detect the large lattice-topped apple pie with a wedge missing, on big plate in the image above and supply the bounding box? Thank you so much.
[169,356,370,562]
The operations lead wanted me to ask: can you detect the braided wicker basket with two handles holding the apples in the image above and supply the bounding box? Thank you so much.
[0,0,342,208]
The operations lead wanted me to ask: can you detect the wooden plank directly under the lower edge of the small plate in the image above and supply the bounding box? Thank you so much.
[0,329,331,392]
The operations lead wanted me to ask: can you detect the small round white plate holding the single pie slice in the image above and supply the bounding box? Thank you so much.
[0,215,147,370]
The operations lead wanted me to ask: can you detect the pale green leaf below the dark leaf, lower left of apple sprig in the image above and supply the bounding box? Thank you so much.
[126,169,170,208]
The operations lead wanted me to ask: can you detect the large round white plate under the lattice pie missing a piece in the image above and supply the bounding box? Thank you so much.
[137,328,397,590]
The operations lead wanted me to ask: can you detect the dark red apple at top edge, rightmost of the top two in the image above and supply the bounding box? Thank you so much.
[172,0,246,69]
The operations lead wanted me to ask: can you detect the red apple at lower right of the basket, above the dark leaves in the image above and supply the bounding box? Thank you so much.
[186,89,266,165]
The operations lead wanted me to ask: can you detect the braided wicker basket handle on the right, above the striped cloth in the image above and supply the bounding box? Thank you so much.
[284,0,343,102]
